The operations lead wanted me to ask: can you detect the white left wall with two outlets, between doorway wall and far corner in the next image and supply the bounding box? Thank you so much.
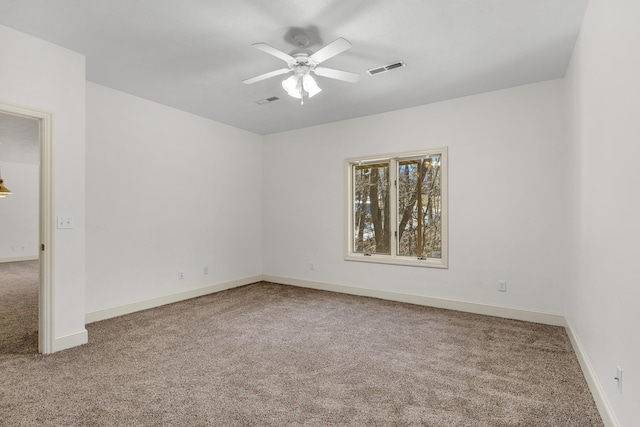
[86,83,262,312]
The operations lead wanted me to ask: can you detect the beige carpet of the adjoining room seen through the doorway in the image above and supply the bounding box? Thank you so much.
[0,260,40,360]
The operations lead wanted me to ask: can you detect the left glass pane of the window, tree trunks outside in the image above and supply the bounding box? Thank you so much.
[353,162,391,254]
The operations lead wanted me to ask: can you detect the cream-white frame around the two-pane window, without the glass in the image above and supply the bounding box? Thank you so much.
[344,147,449,268]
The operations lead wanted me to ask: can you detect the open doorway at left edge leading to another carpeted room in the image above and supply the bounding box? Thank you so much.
[0,103,55,354]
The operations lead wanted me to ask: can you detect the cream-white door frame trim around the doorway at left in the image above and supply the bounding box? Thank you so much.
[0,102,55,354]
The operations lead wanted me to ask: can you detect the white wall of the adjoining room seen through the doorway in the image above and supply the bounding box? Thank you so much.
[0,162,40,261]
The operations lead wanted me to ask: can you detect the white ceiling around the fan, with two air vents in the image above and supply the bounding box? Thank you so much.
[0,0,588,134]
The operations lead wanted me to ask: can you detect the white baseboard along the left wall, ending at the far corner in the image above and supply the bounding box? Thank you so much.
[84,276,262,324]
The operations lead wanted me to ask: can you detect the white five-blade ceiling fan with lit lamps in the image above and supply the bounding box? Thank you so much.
[242,33,360,104]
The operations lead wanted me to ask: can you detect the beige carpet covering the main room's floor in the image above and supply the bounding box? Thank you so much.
[0,283,602,427]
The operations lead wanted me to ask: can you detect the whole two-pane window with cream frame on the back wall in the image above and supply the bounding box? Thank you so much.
[345,148,448,268]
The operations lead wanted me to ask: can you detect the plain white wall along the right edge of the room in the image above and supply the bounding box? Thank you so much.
[566,0,640,426]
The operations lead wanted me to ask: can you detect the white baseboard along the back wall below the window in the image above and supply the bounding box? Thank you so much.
[263,275,566,327]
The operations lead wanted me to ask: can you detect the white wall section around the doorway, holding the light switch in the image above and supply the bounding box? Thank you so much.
[0,26,86,342]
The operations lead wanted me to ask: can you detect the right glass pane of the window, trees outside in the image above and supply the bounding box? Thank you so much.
[397,154,442,258]
